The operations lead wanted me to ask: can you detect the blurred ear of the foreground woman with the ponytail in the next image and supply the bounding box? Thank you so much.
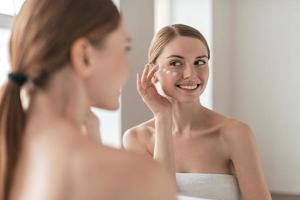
[70,38,92,79]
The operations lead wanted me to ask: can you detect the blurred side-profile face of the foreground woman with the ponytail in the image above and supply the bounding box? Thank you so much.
[88,20,131,110]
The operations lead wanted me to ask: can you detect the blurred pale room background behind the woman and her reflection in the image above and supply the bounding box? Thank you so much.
[0,0,300,200]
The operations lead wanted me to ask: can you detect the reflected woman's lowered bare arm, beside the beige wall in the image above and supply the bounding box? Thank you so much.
[225,121,272,200]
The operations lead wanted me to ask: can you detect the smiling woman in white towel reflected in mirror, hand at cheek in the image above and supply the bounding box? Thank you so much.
[123,24,271,200]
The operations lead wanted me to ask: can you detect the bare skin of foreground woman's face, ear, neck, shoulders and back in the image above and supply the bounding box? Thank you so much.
[10,23,176,200]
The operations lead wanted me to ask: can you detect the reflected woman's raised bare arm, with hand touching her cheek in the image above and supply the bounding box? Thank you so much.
[123,65,175,180]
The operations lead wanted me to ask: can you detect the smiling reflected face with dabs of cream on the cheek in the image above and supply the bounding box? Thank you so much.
[155,36,209,103]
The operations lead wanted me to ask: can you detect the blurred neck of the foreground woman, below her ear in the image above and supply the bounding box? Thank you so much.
[28,67,90,130]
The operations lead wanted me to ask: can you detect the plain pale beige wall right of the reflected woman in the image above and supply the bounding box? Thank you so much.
[214,0,300,194]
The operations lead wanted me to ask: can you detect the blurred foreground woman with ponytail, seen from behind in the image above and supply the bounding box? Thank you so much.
[0,0,176,200]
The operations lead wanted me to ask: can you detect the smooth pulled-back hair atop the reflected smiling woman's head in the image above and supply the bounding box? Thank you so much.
[148,24,210,64]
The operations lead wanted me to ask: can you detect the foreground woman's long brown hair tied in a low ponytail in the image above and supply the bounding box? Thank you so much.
[0,0,120,199]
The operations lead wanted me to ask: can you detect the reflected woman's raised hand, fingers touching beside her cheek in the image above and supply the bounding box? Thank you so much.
[137,64,172,116]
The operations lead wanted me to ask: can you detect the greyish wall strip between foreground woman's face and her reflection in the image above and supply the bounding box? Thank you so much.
[120,0,154,133]
